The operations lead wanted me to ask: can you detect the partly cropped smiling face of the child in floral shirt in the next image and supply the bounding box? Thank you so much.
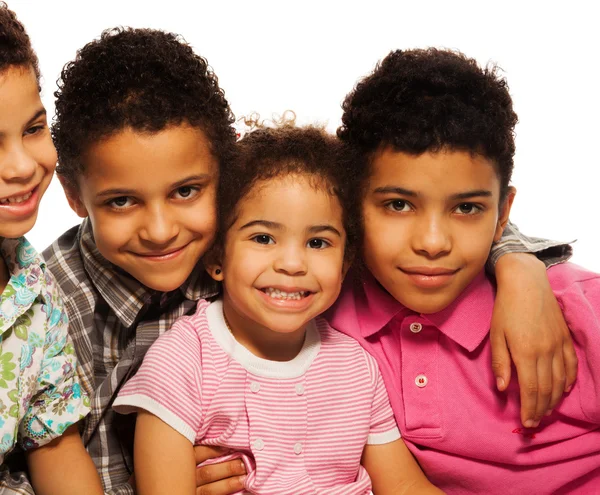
[0,67,56,238]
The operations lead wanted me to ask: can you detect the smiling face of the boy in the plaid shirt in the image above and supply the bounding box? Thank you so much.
[65,124,218,292]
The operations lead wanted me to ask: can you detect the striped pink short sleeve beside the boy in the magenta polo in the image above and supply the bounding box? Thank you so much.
[367,356,400,445]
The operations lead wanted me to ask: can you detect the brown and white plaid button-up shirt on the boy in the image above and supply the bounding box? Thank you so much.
[0,220,572,495]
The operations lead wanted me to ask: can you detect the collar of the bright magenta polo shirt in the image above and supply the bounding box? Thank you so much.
[344,270,495,351]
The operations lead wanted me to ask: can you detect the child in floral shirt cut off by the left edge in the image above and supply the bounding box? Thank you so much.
[0,3,102,495]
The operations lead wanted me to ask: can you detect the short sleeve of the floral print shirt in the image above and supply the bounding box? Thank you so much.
[19,277,90,450]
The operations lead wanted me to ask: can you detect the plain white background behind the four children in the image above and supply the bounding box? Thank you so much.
[8,0,600,271]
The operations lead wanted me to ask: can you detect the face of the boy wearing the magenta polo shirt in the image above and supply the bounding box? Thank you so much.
[363,149,514,313]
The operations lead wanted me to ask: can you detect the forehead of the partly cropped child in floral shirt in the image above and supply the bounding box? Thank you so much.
[0,67,42,131]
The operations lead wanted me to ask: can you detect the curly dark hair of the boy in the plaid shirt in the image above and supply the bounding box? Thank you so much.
[52,28,235,187]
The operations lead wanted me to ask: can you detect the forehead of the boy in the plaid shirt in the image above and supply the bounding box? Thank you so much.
[84,124,218,184]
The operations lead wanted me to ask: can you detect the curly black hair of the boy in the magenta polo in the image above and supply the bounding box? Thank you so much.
[337,48,517,198]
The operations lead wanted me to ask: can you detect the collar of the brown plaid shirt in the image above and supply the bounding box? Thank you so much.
[80,218,218,328]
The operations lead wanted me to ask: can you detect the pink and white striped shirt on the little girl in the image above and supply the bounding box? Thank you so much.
[114,301,400,495]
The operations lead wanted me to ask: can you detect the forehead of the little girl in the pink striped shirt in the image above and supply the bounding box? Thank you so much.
[237,175,342,228]
